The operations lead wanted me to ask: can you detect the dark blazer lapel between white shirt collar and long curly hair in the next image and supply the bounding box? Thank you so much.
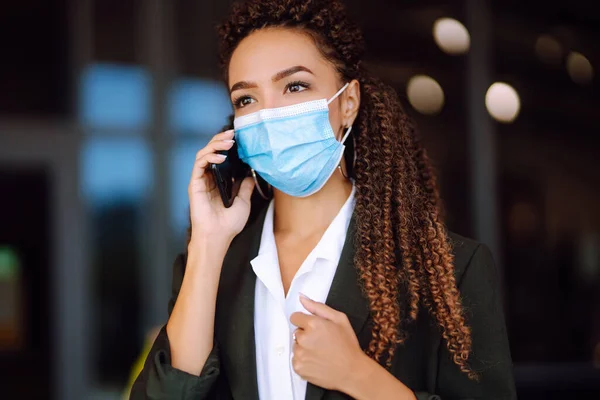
[305,215,369,400]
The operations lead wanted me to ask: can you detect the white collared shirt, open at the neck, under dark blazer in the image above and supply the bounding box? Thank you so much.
[250,187,355,400]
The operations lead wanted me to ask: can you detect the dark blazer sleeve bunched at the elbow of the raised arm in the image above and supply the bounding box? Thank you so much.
[130,254,220,400]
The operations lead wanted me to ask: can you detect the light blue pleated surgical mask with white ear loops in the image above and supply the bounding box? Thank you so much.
[233,83,352,197]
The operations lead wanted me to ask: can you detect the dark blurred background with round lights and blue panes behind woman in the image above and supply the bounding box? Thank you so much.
[0,0,600,400]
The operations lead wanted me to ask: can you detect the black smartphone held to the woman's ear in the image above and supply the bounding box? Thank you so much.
[210,142,250,208]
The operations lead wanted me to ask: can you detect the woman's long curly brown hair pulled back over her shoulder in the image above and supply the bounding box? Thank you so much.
[218,0,478,380]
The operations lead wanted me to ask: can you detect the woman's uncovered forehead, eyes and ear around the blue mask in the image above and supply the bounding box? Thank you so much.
[228,28,360,138]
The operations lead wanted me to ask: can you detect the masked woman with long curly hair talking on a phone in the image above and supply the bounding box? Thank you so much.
[131,0,516,400]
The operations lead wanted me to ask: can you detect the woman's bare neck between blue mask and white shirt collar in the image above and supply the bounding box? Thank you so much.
[273,171,352,236]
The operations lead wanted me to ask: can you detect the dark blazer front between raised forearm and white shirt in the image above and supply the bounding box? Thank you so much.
[215,207,266,400]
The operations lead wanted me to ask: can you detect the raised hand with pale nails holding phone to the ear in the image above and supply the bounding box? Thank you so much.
[188,130,254,242]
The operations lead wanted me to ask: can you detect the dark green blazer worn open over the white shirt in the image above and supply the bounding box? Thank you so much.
[131,211,516,400]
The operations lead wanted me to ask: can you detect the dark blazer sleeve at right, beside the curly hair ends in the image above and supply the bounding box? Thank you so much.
[415,244,517,400]
